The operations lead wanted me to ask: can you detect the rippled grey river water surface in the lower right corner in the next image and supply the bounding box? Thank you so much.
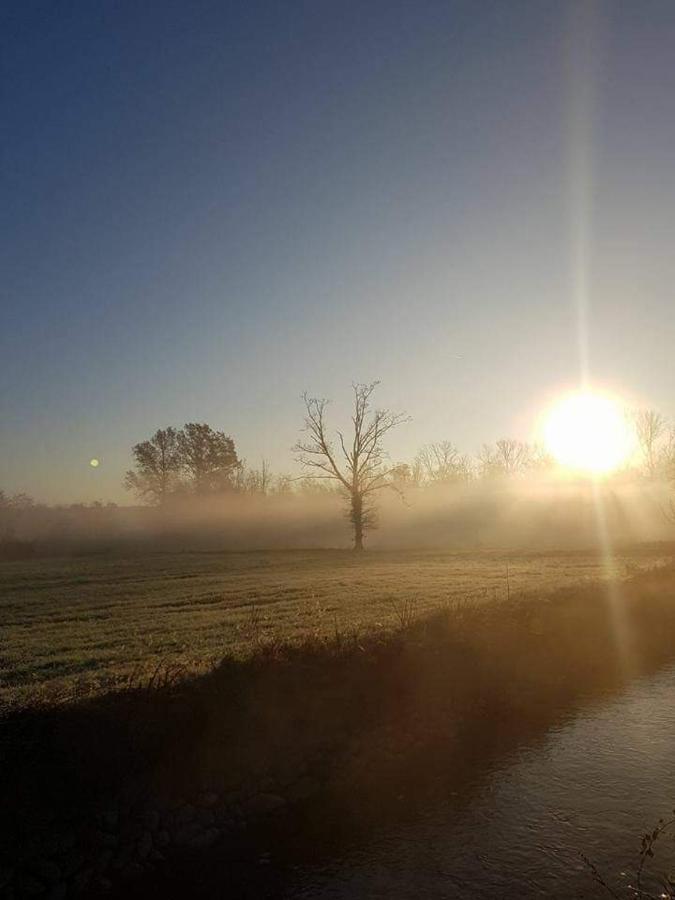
[284,667,675,900]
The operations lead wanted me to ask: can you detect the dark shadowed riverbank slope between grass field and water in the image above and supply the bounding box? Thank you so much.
[0,568,675,896]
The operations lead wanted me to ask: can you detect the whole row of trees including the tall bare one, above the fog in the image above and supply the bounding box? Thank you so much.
[115,381,675,550]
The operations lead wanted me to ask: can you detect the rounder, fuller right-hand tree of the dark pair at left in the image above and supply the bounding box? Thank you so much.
[178,422,241,495]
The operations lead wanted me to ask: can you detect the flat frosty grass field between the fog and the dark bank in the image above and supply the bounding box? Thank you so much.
[0,546,672,704]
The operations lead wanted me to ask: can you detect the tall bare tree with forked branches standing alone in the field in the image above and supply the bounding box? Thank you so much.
[293,381,409,550]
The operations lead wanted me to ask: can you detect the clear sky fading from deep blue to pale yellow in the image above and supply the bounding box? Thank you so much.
[0,0,675,502]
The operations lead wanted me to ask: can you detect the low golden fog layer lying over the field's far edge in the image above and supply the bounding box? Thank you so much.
[0,475,673,553]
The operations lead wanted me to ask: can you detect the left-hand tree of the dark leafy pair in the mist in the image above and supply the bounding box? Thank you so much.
[124,427,183,505]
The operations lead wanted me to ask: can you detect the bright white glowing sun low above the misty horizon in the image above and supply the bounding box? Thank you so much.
[543,393,634,475]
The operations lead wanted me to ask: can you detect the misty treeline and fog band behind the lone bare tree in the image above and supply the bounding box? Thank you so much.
[0,410,675,557]
